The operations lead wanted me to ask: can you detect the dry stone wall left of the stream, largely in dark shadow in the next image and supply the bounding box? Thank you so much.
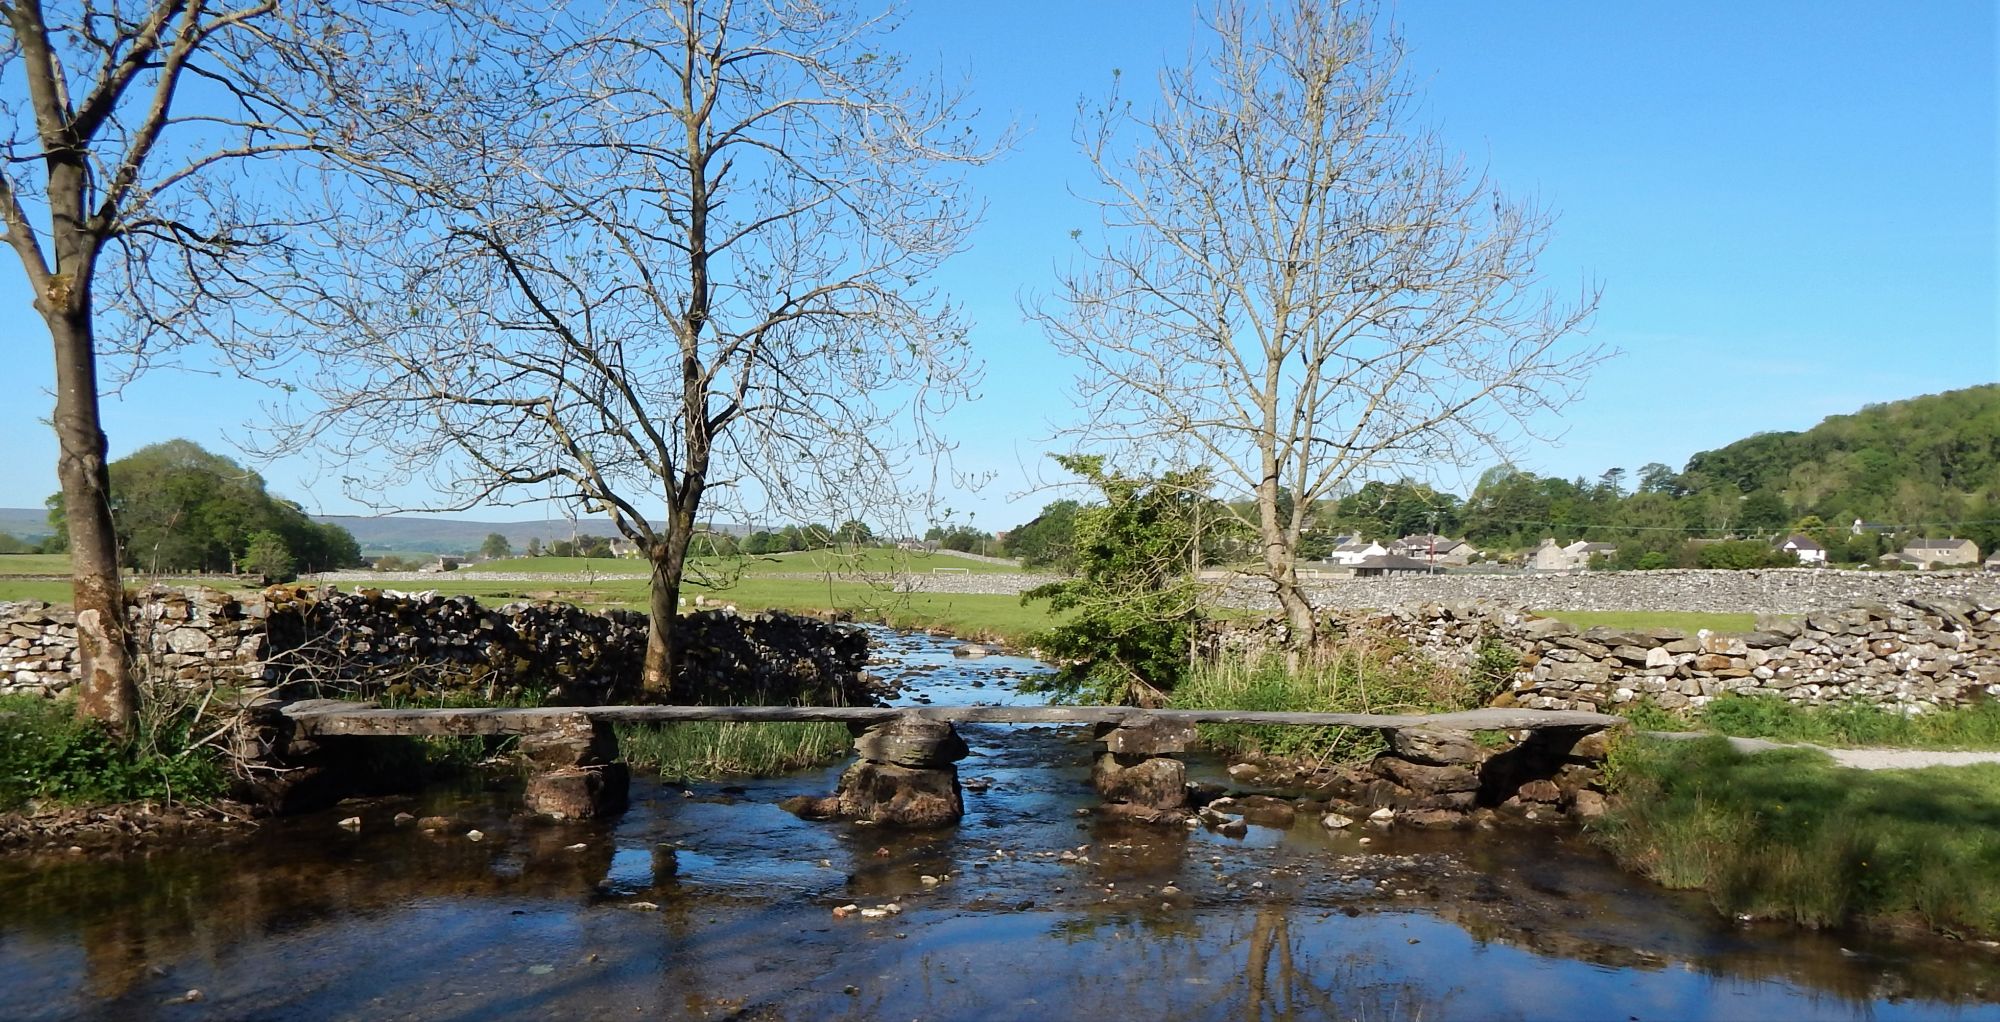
[0,586,872,704]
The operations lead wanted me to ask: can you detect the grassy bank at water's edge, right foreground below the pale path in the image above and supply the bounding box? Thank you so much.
[1596,738,2000,936]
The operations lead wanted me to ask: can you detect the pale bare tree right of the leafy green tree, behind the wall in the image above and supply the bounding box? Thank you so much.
[1034,0,1598,646]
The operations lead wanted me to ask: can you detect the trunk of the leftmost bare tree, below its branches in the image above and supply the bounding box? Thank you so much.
[44,304,138,734]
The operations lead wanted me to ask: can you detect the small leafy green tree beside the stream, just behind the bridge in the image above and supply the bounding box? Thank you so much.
[1022,454,1220,706]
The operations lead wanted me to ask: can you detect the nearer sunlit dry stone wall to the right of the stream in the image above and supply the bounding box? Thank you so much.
[1206,596,2000,712]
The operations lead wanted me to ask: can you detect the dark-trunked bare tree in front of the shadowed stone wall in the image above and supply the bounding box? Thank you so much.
[274,0,988,692]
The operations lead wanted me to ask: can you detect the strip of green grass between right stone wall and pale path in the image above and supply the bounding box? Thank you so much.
[1698,696,2000,750]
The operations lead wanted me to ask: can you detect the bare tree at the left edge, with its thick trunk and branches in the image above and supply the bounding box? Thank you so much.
[0,0,356,728]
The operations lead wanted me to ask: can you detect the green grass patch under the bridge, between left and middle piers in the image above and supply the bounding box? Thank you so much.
[618,720,852,780]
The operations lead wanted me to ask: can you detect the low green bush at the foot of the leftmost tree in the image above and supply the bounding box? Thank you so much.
[0,696,228,812]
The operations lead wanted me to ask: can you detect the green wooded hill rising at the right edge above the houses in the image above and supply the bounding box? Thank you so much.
[1682,384,2000,524]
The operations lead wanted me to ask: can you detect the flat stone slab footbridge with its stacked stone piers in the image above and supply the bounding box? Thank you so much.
[246,700,1622,826]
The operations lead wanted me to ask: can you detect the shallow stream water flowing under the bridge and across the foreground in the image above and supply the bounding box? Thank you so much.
[0,632,2000,1020]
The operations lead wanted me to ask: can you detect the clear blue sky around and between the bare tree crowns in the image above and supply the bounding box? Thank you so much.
[0,0,2000,528]
